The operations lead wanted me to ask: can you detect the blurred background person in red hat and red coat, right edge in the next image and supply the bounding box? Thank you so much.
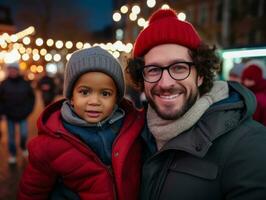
[241,60,266,126]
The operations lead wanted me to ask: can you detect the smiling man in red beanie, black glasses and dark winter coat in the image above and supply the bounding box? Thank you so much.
[127,10,266,200]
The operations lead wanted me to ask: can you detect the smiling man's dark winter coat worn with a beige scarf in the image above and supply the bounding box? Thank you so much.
[141,83,266,200]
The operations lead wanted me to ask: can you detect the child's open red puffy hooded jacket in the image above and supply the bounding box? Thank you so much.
[18,101,144,200]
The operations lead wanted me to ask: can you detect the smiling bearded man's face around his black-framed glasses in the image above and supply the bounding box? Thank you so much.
[144,44,203,120]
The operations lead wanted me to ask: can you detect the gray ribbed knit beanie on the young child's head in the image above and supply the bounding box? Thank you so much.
[64,46,125,102]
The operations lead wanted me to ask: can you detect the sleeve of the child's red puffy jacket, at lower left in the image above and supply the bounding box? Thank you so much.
[18,137,57,200]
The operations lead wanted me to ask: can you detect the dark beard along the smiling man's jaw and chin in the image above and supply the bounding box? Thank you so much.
[147,91,198,120]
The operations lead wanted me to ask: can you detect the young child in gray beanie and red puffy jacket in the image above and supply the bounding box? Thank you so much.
[18,47,144,200]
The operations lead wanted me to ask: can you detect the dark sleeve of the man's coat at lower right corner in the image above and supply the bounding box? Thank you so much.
[222,126,266,200]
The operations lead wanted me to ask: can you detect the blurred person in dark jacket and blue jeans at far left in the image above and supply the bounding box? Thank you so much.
[0,62,35,164]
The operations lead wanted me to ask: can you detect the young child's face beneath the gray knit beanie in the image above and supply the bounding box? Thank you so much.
[71,72,117,123]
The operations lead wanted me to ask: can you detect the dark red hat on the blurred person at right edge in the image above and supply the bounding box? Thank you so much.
[242,64,263,82]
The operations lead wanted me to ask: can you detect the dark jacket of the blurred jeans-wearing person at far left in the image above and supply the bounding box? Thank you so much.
[0,76,35,121]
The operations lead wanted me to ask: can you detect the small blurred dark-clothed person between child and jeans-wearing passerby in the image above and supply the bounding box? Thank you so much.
[37,72,56,107]
